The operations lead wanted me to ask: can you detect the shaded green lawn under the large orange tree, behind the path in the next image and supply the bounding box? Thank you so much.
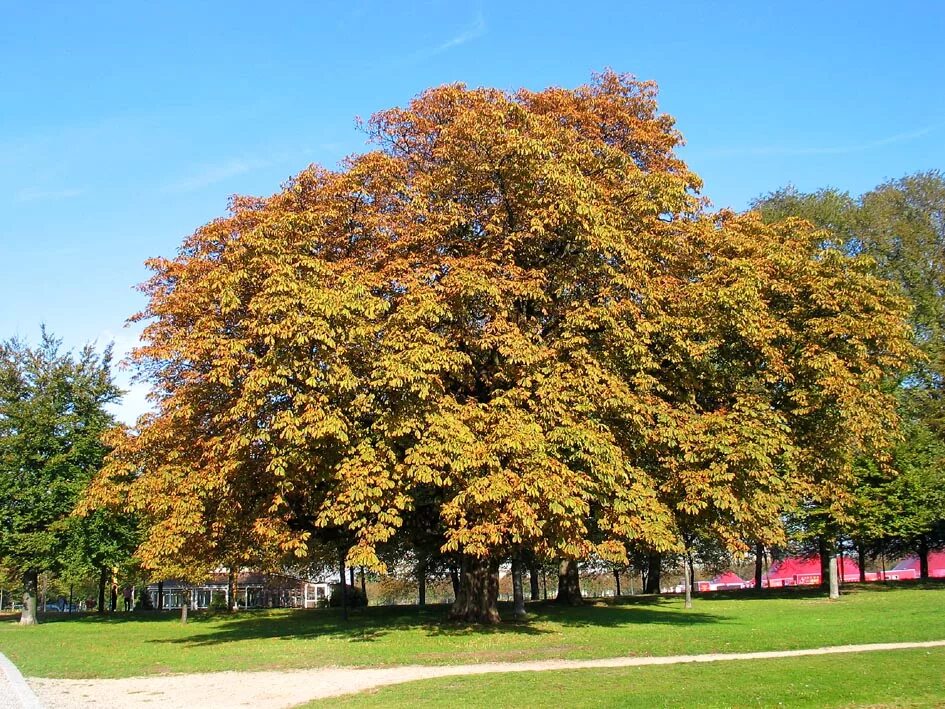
[0,582,945,681]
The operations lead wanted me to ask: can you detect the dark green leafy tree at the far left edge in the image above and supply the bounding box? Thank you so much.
[0,329,120,624]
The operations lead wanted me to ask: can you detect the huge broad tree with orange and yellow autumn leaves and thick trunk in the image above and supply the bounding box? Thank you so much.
[86,73,909,620]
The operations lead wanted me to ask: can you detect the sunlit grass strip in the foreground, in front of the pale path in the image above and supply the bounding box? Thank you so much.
[314,648,945,709]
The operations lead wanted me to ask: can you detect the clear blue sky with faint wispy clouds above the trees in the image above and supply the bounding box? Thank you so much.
[0,0,945,420]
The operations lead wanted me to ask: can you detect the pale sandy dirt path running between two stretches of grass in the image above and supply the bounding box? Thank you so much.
[28,640,945,709]
